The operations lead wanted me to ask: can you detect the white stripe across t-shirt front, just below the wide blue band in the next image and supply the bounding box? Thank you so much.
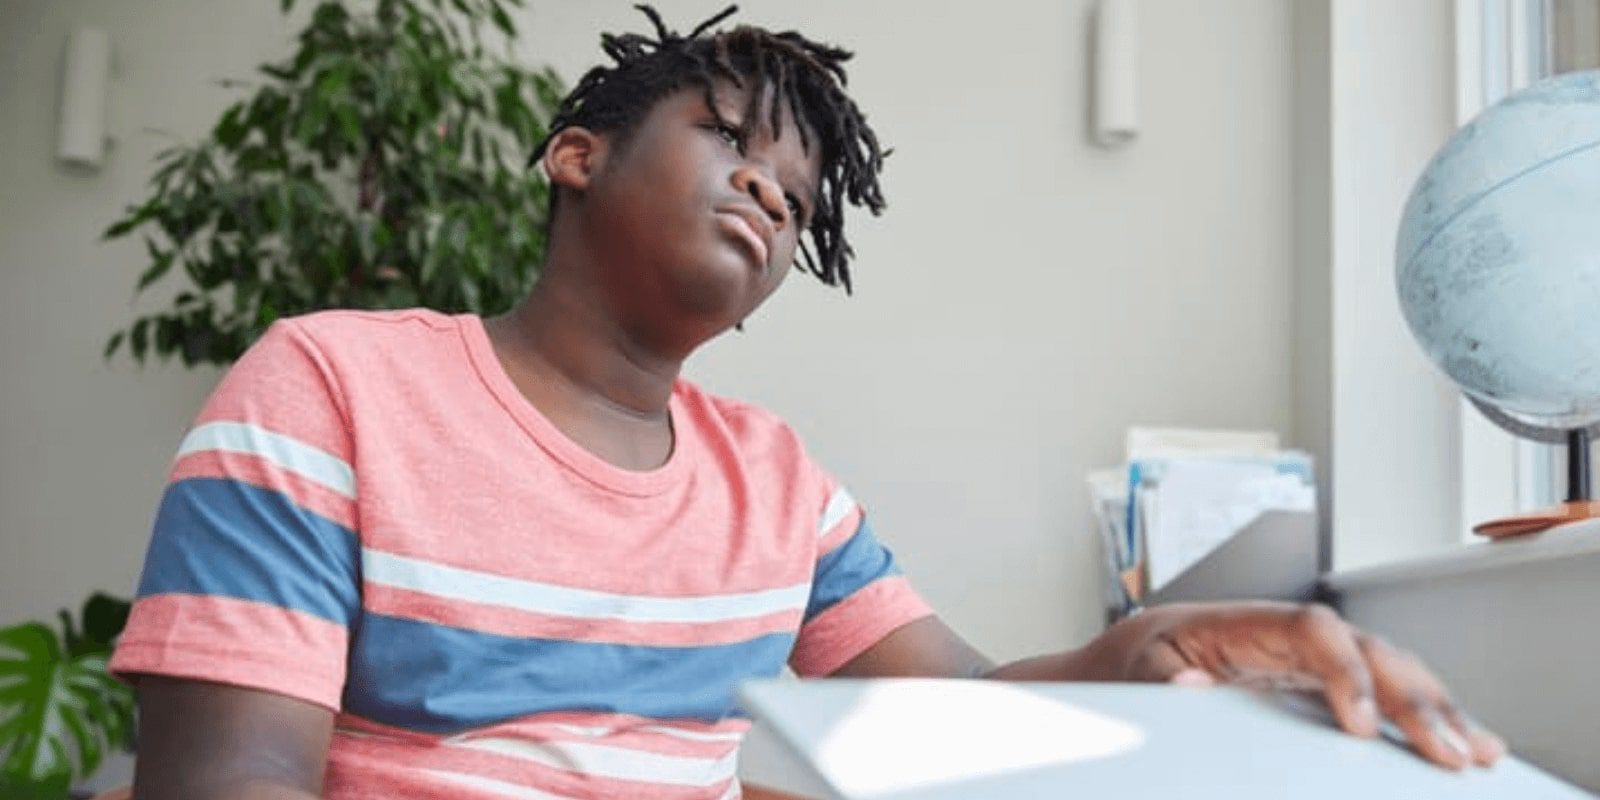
[442,738,739,786]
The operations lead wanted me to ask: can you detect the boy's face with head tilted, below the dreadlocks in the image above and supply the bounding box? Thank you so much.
[582,82,821,350]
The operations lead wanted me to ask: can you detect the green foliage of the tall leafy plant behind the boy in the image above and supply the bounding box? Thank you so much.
[104,0,565,365]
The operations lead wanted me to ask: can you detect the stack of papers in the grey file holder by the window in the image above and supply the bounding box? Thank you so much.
[1088,427,1317,618]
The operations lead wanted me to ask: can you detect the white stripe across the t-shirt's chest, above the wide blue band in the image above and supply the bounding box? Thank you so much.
[362,549,811,622]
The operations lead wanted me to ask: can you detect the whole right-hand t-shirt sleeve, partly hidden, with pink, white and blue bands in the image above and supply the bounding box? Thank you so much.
[789,482,933,677]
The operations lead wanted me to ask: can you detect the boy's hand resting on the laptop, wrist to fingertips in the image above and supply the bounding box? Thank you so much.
[1074,603,1506,770]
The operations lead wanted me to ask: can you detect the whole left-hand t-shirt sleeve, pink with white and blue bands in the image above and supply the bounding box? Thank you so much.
[110,320,360,710]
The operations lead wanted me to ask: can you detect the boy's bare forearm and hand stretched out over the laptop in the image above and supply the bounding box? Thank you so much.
[834,602,1506,770]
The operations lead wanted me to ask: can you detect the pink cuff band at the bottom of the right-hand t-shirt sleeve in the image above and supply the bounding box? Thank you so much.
[789,574,933,678]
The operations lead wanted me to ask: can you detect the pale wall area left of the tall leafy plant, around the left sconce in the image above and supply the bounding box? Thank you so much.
[0,0,300,622]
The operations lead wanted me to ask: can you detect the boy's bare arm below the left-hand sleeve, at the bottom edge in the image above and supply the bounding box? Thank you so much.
[133,675,333,800]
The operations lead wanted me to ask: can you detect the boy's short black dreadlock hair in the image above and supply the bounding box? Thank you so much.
[530,5,886,293]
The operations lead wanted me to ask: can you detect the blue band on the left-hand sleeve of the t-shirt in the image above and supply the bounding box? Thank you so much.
[139,478,360,626]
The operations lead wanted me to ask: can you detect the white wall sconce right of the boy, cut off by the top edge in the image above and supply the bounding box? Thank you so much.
[1090,0,1139,147]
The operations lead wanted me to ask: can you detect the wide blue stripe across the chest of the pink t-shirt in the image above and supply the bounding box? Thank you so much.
[344,611,794,733]
